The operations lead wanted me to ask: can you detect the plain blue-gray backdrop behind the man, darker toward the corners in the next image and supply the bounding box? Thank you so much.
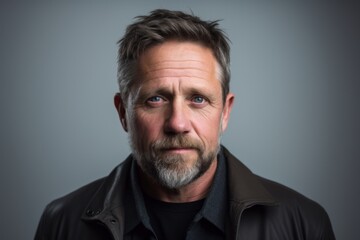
[0,0,360,239]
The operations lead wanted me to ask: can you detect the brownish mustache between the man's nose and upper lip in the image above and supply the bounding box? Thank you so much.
[152,135,203,151]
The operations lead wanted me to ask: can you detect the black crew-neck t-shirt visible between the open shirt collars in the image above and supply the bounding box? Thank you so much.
[144,196,204,240]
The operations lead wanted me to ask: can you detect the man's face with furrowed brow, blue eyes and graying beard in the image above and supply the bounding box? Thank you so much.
[115,41,233,189]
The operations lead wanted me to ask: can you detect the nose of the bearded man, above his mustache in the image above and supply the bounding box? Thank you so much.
[164,102,191,134]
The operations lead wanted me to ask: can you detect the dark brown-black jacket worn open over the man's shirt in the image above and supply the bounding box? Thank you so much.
[35,148,335,240]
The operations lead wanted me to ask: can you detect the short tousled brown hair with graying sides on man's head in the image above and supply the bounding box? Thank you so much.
[117,9,230,102]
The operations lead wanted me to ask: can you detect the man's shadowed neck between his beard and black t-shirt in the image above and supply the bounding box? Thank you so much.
[139,160,217,203]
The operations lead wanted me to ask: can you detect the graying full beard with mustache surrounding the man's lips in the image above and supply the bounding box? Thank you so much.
[130,134,220,190]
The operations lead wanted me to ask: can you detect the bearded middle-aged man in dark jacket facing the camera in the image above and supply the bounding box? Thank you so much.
[35,10,334,240]
